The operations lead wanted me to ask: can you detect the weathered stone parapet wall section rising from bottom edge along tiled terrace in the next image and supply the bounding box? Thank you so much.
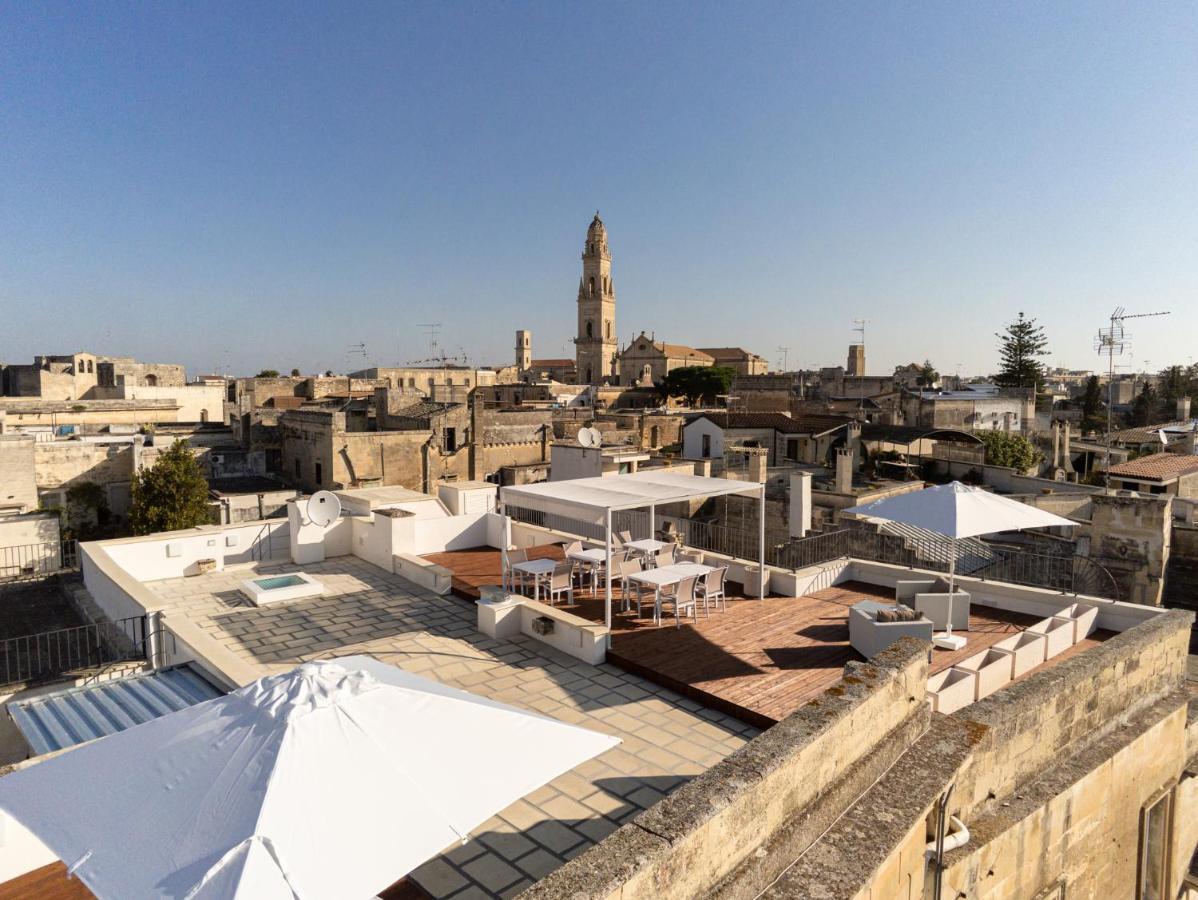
[521,639,927,900]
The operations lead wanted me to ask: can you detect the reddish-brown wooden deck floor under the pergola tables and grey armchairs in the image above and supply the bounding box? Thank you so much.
[426,546,1113,727]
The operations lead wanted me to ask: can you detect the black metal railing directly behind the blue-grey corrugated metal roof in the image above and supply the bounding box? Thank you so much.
[0,616,147,685]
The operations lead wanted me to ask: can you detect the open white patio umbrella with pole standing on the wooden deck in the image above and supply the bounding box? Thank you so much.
[845,482,1077,646]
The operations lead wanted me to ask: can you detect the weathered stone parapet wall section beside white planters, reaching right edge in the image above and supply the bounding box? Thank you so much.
[956,610,1193,817]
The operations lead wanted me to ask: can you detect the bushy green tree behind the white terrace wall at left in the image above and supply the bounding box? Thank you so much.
[129,441,212,534]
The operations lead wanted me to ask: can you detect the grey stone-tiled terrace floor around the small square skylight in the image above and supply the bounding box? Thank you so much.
[140,556,756,900]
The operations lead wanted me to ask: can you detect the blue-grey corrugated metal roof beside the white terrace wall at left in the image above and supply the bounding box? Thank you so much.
[8,665,224,756]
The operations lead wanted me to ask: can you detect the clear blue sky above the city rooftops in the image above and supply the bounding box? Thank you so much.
[0,1,1198,374]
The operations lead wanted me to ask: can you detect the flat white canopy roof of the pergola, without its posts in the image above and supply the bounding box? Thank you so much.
[501,469,761,523]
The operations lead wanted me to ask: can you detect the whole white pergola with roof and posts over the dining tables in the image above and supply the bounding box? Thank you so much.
[500,469,766,628]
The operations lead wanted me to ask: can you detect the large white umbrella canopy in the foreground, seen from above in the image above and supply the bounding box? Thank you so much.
[0,656,619,900]
